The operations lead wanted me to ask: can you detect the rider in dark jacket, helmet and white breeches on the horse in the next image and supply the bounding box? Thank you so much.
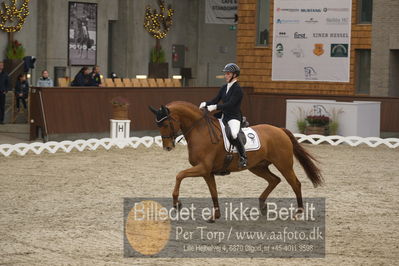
[199,63,247,168]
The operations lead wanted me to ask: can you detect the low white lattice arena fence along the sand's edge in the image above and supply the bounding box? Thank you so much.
[0,133,399,156]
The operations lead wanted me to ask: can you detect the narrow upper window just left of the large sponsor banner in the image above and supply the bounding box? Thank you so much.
[256,0,270,46]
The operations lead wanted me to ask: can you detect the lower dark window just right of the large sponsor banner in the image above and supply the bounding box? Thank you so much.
[356,49,371,95]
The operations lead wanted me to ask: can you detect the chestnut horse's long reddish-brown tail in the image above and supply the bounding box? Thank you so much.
[282,128,323,187]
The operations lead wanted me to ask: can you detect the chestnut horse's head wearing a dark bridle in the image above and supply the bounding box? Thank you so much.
[148,105,180,151]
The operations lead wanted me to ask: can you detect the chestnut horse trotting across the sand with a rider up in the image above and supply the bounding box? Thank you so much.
[149,101,323,222]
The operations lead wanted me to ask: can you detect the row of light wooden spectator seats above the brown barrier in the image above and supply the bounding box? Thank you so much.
[57,77,182,87]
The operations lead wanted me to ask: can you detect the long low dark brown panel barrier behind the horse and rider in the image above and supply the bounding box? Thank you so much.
[29,87,399,140]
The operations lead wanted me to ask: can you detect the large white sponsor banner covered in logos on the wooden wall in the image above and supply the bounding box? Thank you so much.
[272,0,352,82]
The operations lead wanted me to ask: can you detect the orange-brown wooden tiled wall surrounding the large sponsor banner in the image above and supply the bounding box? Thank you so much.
[237,0,371,95]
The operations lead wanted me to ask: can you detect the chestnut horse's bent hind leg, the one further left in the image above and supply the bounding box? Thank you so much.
[249,163,281,214]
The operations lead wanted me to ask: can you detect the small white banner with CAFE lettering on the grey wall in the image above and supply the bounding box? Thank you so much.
[205,0,238,24]
